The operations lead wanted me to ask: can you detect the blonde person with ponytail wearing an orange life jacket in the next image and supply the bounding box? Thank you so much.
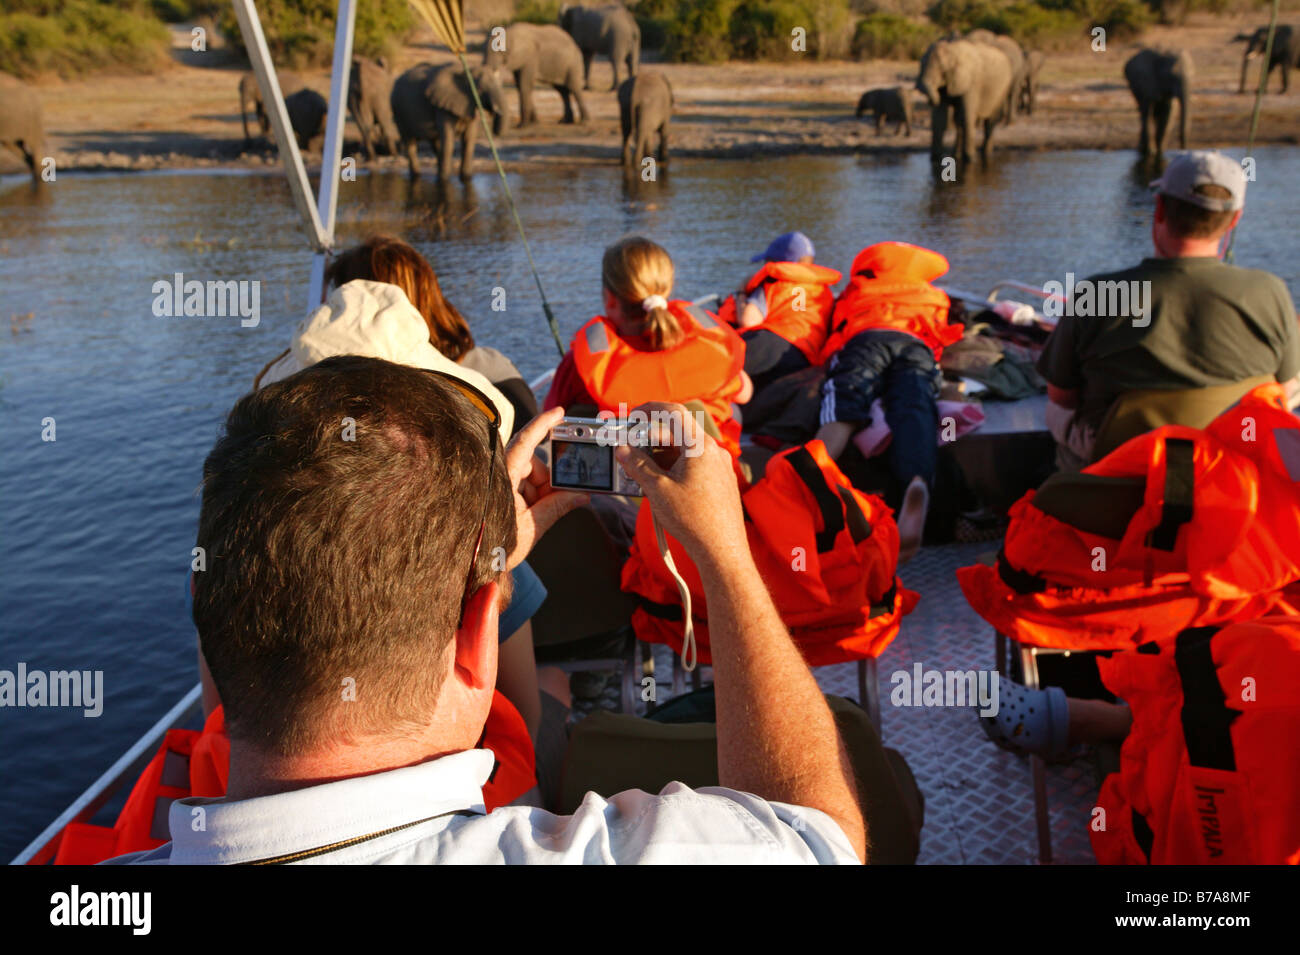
[545,236,754,456]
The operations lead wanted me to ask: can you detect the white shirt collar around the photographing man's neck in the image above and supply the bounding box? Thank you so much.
[168,750,495,865]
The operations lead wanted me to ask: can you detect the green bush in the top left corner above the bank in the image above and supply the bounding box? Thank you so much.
[0,0,172,78]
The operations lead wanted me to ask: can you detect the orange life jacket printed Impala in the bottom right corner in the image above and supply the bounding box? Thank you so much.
[1089,616,1300,865]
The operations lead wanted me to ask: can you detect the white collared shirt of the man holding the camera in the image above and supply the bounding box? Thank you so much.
[107,750,858,865]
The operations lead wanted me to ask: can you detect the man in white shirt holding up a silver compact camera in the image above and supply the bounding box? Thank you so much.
[111,356,866,864]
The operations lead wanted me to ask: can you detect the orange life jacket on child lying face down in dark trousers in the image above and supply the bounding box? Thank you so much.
[822,242,962,363]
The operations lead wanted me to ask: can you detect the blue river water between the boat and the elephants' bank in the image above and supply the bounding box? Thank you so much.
[0,147,1300,859]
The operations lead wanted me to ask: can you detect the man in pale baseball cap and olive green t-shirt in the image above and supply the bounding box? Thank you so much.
[1037,151,1300,470]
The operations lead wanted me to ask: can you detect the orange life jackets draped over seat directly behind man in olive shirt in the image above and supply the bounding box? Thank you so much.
[957,385,1300,650]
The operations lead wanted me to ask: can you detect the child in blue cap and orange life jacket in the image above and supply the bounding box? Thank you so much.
[720,233,840,388]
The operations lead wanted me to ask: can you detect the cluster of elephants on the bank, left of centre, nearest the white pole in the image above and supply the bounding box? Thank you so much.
[239,4,660,179]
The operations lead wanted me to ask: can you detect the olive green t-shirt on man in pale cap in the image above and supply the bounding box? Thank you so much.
[1037,257,1300,427]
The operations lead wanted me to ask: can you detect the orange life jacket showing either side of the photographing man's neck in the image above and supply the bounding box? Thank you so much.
[43,691,537,865]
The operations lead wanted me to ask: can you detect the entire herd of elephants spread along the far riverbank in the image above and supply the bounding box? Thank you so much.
[0,13,1300,179]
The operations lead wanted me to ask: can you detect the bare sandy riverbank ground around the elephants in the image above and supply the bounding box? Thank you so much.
[12,17,1300,170]
